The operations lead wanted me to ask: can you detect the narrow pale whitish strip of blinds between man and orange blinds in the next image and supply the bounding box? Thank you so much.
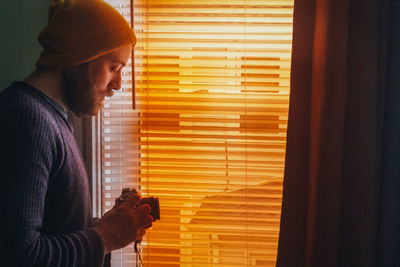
[100,0,139,267]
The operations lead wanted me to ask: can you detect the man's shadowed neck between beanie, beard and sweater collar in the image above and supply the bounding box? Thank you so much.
[23,69,66,110]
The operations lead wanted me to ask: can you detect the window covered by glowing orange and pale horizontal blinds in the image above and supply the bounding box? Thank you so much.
[99,0,294,267]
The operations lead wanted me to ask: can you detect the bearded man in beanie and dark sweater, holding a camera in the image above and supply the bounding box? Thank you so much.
[0,0,153,267]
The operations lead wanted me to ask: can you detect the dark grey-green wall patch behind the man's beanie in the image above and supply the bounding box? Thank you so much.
[0,0,50,90]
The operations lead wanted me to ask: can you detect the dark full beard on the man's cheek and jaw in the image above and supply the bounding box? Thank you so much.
[61,62,101,116]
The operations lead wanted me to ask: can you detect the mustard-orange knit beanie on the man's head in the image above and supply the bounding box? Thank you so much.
[36,0,136,69]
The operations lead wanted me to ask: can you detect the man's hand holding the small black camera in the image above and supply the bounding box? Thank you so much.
[94,194,153,254]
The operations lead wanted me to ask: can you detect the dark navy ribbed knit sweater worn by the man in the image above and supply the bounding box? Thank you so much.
[0,82,104,267]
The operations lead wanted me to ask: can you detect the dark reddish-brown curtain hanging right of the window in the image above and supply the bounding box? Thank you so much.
[277,0,400,267]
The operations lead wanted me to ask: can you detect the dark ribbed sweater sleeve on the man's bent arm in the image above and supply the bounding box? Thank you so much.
[0,103,104,267]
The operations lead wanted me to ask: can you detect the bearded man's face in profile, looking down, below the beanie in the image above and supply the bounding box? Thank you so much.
[62,45,131,116]
